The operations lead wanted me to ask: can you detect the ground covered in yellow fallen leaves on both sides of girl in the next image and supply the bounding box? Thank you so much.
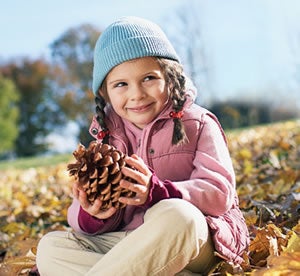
[0,120,300,276]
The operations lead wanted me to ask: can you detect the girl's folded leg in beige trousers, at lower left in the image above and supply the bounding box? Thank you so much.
[36,231,126,276]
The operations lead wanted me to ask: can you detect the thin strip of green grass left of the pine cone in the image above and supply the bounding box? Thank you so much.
[0,153,72,171]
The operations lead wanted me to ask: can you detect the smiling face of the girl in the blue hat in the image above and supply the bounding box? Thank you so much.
[100,57,169,129]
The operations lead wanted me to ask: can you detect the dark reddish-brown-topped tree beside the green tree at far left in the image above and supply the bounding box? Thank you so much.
[0,59,62,156]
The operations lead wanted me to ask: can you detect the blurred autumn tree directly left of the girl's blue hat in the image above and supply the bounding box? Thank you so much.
[51,24,100,144]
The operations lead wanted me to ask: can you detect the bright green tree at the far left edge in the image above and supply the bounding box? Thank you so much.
[0,74,19,156]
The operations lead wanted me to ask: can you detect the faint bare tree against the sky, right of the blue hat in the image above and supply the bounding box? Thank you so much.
[166,1,215,104]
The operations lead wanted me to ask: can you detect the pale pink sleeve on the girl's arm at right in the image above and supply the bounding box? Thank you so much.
[174,114,236,216]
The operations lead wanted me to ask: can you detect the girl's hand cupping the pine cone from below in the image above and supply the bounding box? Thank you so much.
[72,182,117,219]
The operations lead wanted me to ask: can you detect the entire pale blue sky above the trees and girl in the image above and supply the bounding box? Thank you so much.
[0,0,300,104]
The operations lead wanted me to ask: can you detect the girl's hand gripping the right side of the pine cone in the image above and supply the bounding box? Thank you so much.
[119,154,152,205]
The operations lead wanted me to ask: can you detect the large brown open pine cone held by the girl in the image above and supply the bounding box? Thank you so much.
[67,141,135,210]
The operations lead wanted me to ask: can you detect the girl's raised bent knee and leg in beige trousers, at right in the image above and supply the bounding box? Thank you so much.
[86,199,214,276]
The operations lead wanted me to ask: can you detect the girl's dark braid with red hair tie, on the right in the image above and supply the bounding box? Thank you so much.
[157,58,188,145]
